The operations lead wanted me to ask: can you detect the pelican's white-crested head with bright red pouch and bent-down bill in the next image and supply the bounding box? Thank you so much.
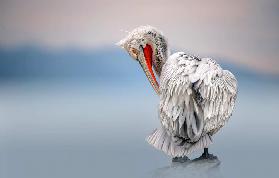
[117,26,168,94]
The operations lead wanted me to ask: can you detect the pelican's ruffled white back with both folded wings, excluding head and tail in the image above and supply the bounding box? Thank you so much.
[160,52,237,144]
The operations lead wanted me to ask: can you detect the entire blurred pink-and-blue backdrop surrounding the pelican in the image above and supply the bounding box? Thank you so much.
[0,0,279,178]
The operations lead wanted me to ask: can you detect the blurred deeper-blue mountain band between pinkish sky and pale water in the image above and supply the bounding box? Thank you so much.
[0,46,279,85]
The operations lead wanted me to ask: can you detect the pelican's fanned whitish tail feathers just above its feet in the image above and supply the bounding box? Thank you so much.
[146,128,212,157]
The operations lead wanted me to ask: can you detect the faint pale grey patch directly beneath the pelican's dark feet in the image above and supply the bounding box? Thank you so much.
[152,158,223,178]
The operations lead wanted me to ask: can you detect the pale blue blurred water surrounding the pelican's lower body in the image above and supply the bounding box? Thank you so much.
[0,80,279,178]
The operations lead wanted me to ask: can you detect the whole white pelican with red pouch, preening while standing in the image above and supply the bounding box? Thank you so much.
[118,26,237,162]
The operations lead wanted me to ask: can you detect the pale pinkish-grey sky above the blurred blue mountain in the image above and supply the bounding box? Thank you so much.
[0,0,279,74]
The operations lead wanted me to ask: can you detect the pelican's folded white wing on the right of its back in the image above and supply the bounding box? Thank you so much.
[193,58,237,134]
